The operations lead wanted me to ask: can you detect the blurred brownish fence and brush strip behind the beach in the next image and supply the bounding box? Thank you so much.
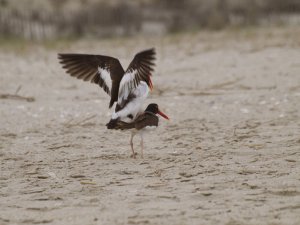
[0,0,300,41]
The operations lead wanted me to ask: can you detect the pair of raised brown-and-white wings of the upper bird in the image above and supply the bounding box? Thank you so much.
[58,49,155,108]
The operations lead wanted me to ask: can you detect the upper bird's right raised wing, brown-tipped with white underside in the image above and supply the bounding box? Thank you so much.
[118,48,155,105]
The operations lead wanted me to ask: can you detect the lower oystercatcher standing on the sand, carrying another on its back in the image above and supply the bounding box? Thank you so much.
[112,103,169,158]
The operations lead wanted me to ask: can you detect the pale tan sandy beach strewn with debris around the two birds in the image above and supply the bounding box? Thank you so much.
[0,28,300,225]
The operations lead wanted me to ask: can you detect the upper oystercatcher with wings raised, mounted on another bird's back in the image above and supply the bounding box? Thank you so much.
[58,48,155,124]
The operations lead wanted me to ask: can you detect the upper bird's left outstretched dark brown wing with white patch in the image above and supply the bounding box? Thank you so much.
[58,54,124,107]
